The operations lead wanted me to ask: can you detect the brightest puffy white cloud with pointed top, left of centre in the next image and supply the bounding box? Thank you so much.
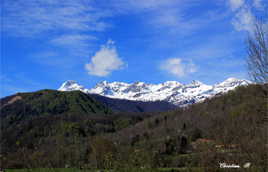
[85,40,124,77]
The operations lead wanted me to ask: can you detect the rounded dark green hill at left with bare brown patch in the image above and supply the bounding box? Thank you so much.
[1,90,111,118]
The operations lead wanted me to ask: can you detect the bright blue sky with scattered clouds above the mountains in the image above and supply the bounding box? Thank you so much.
[0,0,268,97]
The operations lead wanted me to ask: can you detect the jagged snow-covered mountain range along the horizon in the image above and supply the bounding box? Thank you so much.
[58,78,251,106]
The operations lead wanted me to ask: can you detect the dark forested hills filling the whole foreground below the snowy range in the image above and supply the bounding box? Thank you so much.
[0,84,268,171]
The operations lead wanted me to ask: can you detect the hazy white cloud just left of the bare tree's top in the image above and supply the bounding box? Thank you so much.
[232,8,255,33]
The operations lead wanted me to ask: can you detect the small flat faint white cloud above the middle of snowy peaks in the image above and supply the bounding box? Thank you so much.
[160,58,197,77]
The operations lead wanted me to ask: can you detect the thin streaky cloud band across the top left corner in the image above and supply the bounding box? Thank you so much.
[3,0,111,37]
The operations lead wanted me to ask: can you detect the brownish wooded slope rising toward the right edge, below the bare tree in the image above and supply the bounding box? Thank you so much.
[107,85,268,168]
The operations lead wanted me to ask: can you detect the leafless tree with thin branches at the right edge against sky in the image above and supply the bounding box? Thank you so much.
[247,21,268,83]
